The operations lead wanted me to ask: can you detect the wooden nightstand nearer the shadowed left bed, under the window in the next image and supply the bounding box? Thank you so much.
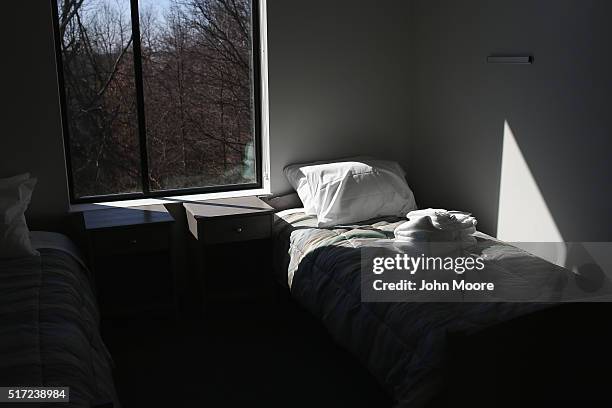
[83,205,176,317]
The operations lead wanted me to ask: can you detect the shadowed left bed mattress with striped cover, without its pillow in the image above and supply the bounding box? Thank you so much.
[0,232,119,407]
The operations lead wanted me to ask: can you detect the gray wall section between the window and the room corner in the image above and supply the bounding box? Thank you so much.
[268,0,412,192]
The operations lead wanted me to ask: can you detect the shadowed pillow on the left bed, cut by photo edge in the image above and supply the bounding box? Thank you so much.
[0,173,39,258]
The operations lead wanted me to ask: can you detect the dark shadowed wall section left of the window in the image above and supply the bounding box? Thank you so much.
[0,0,68,228]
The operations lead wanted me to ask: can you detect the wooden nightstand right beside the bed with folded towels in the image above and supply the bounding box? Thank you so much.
[183,197,274,304]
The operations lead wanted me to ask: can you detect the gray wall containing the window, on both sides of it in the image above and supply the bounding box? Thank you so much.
[0,0,409,228]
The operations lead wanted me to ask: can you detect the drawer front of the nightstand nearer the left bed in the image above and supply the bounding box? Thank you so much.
[91,225,170,256]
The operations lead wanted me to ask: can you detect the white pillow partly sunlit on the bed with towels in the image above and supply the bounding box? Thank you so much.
[284,157,416,227]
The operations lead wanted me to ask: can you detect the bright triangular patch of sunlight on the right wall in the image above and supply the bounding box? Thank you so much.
[497,121,567,265]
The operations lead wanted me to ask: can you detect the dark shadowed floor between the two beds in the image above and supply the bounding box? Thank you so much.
[103,301,391,408]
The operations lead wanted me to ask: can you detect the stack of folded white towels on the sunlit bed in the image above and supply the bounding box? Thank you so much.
[394,208,477,246]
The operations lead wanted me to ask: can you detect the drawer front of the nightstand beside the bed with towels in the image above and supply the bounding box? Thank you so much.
[198,214,272,244]
